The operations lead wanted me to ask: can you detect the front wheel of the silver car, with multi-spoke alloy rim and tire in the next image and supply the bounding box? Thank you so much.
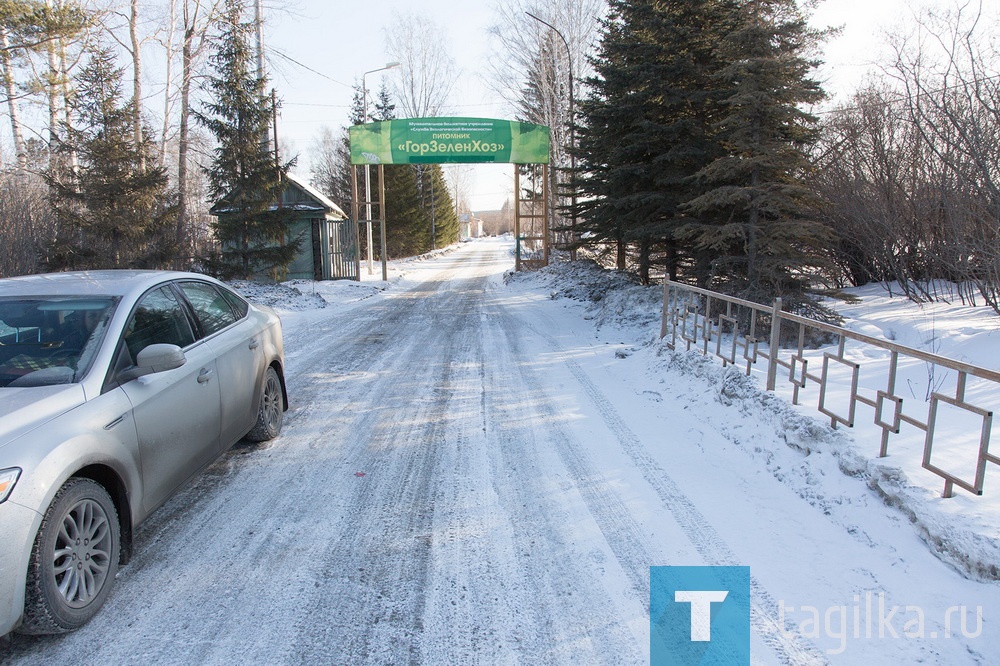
[18,478,121,634]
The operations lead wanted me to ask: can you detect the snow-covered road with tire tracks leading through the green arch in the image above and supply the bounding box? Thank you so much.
[0,241,1000,664]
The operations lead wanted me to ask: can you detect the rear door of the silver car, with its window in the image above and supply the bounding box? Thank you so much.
[178,280,264,446]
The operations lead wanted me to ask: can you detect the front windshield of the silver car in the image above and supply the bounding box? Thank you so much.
[0,296,117,387]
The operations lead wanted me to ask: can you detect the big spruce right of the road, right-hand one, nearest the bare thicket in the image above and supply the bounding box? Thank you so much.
[682,0,833,306]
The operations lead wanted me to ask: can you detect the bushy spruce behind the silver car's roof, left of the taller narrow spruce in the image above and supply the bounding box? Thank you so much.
[45,49,176,269]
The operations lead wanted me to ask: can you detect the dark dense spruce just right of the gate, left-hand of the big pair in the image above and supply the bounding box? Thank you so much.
[578,0,736,282]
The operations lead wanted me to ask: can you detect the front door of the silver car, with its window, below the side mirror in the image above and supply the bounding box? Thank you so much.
[122,286,221,512]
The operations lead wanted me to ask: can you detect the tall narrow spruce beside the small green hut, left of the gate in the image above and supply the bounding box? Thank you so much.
[194,0,302,279]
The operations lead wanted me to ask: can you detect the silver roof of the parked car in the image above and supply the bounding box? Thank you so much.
[0,270,221,297]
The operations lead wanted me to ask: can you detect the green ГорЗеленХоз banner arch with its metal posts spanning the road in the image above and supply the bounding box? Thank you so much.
[349,118,551,281]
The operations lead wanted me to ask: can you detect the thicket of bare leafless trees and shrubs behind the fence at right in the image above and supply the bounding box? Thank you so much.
[817,2,1000,312]
